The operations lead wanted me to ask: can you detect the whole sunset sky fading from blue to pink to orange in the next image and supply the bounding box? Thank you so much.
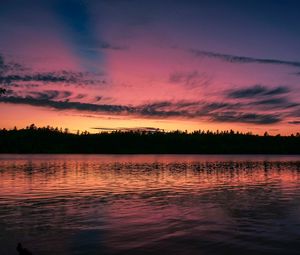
[0,0,300,135]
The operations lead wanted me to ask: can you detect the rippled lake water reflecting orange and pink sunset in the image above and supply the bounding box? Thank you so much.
[0,155,300,255]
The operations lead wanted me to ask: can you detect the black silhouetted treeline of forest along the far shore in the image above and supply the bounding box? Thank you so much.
[0,124,300,154]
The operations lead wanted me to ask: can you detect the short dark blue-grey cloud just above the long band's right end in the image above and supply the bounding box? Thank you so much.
[227,85,290,98]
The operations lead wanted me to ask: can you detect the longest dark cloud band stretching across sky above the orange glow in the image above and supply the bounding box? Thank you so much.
[0,94,282,124]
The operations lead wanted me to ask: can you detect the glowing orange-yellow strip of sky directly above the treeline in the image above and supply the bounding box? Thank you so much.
[0,104,299,135]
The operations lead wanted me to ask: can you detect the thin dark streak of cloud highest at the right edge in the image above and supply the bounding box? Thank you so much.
[189,49,300,67]
